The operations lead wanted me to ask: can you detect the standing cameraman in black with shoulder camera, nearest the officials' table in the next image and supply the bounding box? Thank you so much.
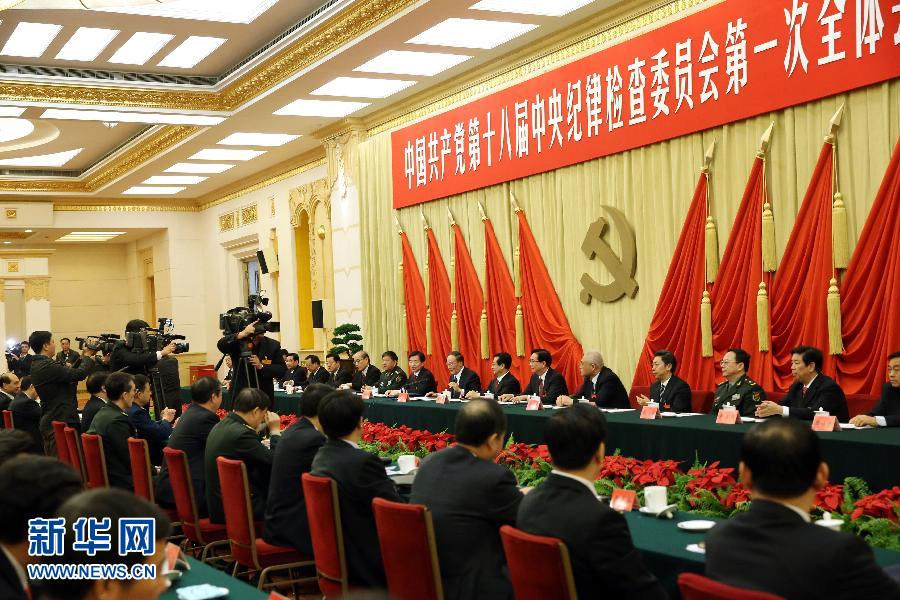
[216,320,286,409]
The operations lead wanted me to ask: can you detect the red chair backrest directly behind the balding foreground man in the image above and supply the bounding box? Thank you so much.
[372,498,444,600]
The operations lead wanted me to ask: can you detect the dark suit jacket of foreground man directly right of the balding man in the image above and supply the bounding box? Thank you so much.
[516,473,666,598]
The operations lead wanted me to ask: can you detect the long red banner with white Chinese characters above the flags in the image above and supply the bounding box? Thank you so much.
[391,0,900,208]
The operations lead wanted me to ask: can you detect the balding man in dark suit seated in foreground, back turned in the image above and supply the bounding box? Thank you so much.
[409,399,522,600]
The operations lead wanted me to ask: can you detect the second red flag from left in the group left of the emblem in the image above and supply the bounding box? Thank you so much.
[428,227,453,390]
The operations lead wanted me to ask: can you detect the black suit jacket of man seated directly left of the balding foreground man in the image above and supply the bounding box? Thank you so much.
[310,439,403,588]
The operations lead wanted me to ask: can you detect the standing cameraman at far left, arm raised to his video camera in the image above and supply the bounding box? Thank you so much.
[28,331,96,456]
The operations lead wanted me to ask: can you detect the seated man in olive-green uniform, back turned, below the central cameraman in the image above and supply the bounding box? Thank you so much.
[203,386,282,525]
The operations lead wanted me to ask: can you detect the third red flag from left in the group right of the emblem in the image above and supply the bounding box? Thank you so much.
[770,142,835,390]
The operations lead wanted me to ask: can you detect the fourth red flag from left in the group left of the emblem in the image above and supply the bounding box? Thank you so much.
[484,219,531,388]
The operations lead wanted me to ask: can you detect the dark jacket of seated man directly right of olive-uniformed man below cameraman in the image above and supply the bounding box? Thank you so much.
[263,417,325,555]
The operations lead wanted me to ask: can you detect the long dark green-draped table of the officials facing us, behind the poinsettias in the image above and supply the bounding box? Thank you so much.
[182,388,900,492]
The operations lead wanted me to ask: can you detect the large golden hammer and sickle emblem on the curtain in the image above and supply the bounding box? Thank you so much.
[580,206,638,304]
